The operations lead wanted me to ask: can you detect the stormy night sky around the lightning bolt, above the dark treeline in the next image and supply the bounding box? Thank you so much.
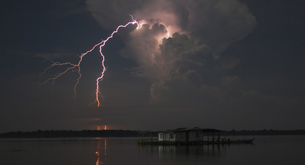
[0,0,305,132]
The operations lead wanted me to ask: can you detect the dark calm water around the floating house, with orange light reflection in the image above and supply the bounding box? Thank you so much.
[0,136,305,165]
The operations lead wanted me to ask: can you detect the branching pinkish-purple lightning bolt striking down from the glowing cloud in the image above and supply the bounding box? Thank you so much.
[41,15,139,107]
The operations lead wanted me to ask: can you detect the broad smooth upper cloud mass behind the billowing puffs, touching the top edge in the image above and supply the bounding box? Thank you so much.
[87,0,256,53]
